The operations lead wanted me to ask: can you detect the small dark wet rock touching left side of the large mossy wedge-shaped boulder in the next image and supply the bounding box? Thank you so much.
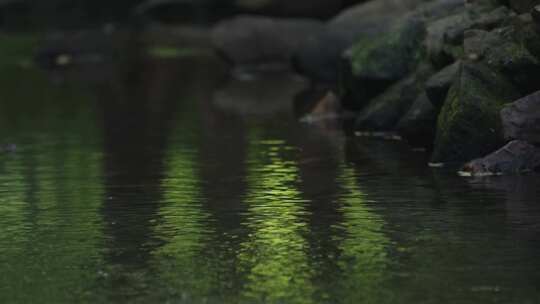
[396,93,438,148]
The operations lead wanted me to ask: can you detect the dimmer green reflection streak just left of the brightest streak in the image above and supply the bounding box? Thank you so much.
[153,138,216,302]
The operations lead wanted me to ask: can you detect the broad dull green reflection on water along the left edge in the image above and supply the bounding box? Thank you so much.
[0,69,104,303]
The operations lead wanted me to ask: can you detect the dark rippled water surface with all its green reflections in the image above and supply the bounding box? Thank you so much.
[0,52,540,304]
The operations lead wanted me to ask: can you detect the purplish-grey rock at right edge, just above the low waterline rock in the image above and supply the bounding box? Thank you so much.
[501,91,540,144]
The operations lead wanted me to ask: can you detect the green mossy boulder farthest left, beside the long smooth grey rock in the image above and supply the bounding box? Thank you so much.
[342,18,426,110]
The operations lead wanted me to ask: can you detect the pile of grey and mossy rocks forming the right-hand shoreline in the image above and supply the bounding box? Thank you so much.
[211,0,540,175]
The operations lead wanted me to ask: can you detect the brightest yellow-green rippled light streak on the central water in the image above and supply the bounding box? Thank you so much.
[238,134,313,303]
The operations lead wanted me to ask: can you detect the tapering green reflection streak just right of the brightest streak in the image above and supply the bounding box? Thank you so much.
[337,165,392,303]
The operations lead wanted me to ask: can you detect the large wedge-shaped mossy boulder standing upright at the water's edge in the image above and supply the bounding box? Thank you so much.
[431,62,519,163]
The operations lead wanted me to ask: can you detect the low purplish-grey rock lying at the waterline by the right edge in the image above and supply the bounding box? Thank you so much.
[460,140,540,176]
